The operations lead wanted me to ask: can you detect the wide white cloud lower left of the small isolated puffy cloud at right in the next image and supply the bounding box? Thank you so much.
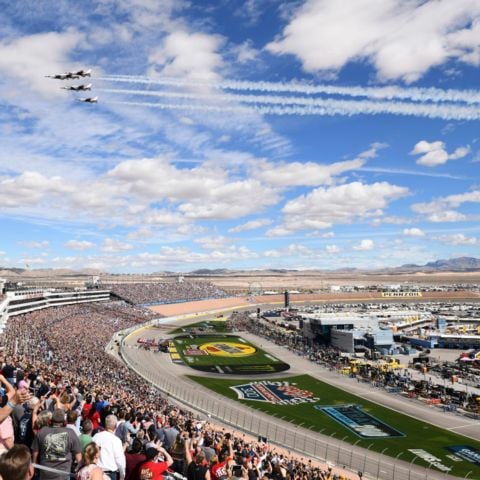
[267,182,409,236]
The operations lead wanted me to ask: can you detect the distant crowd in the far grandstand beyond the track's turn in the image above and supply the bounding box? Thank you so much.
[101,280,227,305]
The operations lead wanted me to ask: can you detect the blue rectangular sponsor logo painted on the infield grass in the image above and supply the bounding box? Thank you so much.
[315,404,405,438]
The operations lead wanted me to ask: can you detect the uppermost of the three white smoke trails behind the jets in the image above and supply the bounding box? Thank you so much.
[97,75,480,104]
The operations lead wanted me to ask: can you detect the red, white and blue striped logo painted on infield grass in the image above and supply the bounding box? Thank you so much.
[230,381,320,405]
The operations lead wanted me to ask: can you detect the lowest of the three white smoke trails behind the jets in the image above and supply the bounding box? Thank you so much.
[110,100,480,120]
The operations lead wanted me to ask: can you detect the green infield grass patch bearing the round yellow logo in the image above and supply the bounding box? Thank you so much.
[172,335,290,375]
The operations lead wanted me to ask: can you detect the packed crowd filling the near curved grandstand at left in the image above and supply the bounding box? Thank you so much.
[0,302,357,480]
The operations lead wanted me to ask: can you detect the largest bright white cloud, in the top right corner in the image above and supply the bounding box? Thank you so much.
[266,0,480,82]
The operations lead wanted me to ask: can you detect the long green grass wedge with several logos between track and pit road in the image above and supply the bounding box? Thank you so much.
[189,375,480,479]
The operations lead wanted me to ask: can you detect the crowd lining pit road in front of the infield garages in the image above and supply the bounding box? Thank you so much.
[228,312,480,414]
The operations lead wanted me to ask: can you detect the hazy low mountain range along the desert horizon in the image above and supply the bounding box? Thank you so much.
[0,257,480,278]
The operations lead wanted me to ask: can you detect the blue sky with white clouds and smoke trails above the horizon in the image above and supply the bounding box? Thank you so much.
[0,0,480,272]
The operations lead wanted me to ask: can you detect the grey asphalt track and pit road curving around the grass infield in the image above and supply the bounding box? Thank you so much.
[118,307,480,480]
